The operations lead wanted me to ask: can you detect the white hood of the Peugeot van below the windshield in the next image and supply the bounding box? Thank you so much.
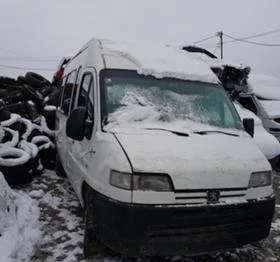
[115,131,271,190]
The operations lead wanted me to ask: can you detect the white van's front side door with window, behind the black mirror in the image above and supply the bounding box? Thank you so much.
[68,69,96,192]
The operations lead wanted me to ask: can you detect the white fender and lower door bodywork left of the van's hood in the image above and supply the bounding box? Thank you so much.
[71,132,132,204]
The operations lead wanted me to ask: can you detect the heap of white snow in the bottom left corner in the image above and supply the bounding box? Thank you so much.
[0,173,41,262]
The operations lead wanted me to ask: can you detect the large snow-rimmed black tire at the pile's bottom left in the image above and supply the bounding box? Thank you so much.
[0,148,33,186]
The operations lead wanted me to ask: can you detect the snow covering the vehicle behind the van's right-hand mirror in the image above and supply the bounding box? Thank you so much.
[234,103,280,159]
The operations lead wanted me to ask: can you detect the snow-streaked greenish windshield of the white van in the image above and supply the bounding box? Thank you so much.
[101,70,242,129]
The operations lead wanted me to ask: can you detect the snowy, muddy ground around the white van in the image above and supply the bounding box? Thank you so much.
[0,171,280,262]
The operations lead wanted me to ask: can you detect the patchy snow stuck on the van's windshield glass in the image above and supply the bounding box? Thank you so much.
[108,86,210,124]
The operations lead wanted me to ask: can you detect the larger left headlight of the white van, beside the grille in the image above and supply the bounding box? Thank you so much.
[110,170,173,192]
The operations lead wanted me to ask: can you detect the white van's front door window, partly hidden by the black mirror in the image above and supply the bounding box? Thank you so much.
[78,73,94,139]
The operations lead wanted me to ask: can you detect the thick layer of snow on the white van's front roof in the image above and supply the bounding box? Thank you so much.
[101,40,218,83]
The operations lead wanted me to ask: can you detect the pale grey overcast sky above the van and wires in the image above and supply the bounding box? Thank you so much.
[0,0,280,81]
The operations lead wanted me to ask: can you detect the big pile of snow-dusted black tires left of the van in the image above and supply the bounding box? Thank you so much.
[0,72,61,186]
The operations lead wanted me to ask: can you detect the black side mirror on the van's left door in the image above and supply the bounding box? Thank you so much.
[66,107,87,141]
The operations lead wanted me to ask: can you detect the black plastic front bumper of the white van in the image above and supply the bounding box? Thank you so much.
[91,189,275,257]
